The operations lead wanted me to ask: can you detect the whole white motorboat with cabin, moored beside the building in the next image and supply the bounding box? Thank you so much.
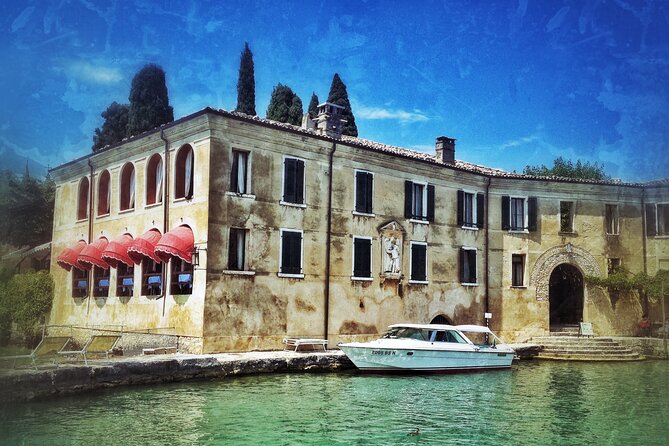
[338,324,515,372]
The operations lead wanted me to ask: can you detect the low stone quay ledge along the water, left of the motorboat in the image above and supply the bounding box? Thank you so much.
[0,351,354,402]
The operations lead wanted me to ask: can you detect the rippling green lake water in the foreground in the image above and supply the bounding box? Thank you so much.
[0,361,669,446]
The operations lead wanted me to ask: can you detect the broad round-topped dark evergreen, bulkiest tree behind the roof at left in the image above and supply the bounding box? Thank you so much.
[127,64,174,136]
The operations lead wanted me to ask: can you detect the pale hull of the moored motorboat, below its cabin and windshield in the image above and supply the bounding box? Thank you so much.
[339,344,514,373]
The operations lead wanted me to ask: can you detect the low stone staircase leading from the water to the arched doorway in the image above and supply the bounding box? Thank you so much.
[529,331,644,361]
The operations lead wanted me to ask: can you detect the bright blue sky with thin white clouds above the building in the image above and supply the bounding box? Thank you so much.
[0,0,669,181]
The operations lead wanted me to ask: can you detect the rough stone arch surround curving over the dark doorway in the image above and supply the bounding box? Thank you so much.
[530,243,602,304]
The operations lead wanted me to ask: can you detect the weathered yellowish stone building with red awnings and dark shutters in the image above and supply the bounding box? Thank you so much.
[50,104,669,352]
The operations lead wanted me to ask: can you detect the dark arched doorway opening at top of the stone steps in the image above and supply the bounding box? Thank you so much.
[548,263,583,331]
